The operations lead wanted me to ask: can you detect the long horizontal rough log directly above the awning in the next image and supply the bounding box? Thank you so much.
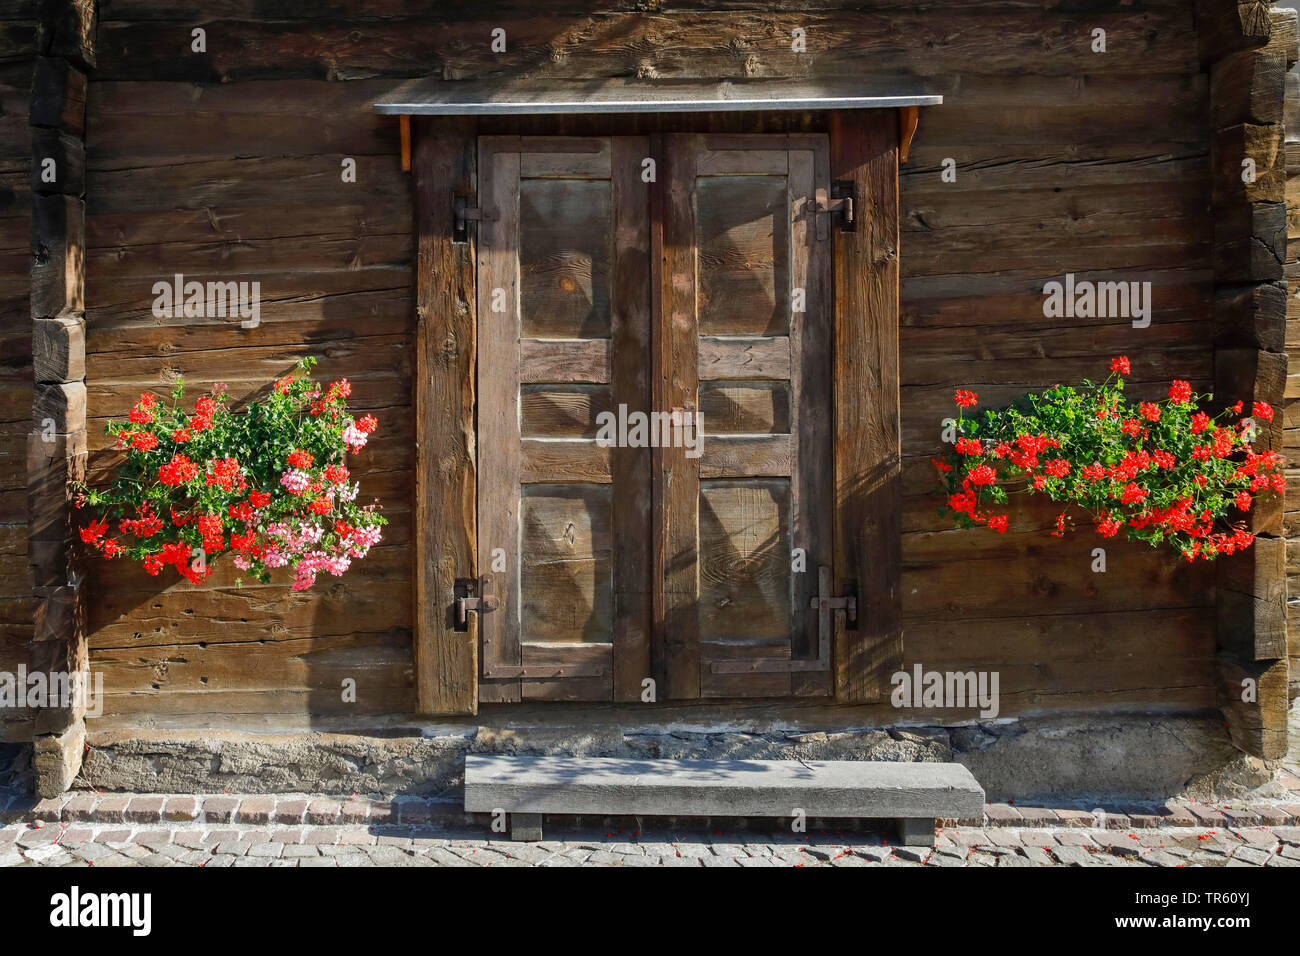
[98,8,1199,83]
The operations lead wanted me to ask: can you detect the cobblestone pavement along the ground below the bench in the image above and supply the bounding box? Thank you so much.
[0,822,1300,866]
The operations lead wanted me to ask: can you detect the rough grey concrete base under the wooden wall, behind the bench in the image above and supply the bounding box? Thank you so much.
[61,717,1281,801]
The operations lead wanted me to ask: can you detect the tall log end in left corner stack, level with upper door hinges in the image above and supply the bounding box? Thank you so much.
[31,195,86,319]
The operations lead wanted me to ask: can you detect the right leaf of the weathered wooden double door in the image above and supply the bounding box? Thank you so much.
[659,135,833,698]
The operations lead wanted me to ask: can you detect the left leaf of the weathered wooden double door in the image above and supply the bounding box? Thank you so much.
[478,137,650,701]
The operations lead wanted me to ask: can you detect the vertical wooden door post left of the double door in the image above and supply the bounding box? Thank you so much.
[413,118,478,714]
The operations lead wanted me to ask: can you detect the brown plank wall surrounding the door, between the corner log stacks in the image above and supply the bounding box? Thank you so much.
[78,0,1216,722]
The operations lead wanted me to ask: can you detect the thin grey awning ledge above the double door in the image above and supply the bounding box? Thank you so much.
[374,77,944,116]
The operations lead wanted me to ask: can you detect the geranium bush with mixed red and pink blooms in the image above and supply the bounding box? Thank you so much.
[75,359,386,591]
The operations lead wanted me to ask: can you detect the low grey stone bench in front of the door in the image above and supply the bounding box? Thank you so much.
[465,754,984,847]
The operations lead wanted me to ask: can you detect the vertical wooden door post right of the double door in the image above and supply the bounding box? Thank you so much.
[831,113,902,702]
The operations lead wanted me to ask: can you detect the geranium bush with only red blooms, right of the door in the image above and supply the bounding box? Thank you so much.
[933,355,1286,561]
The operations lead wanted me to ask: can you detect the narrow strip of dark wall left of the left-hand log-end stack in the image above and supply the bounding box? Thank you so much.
[0,0,36,740]
